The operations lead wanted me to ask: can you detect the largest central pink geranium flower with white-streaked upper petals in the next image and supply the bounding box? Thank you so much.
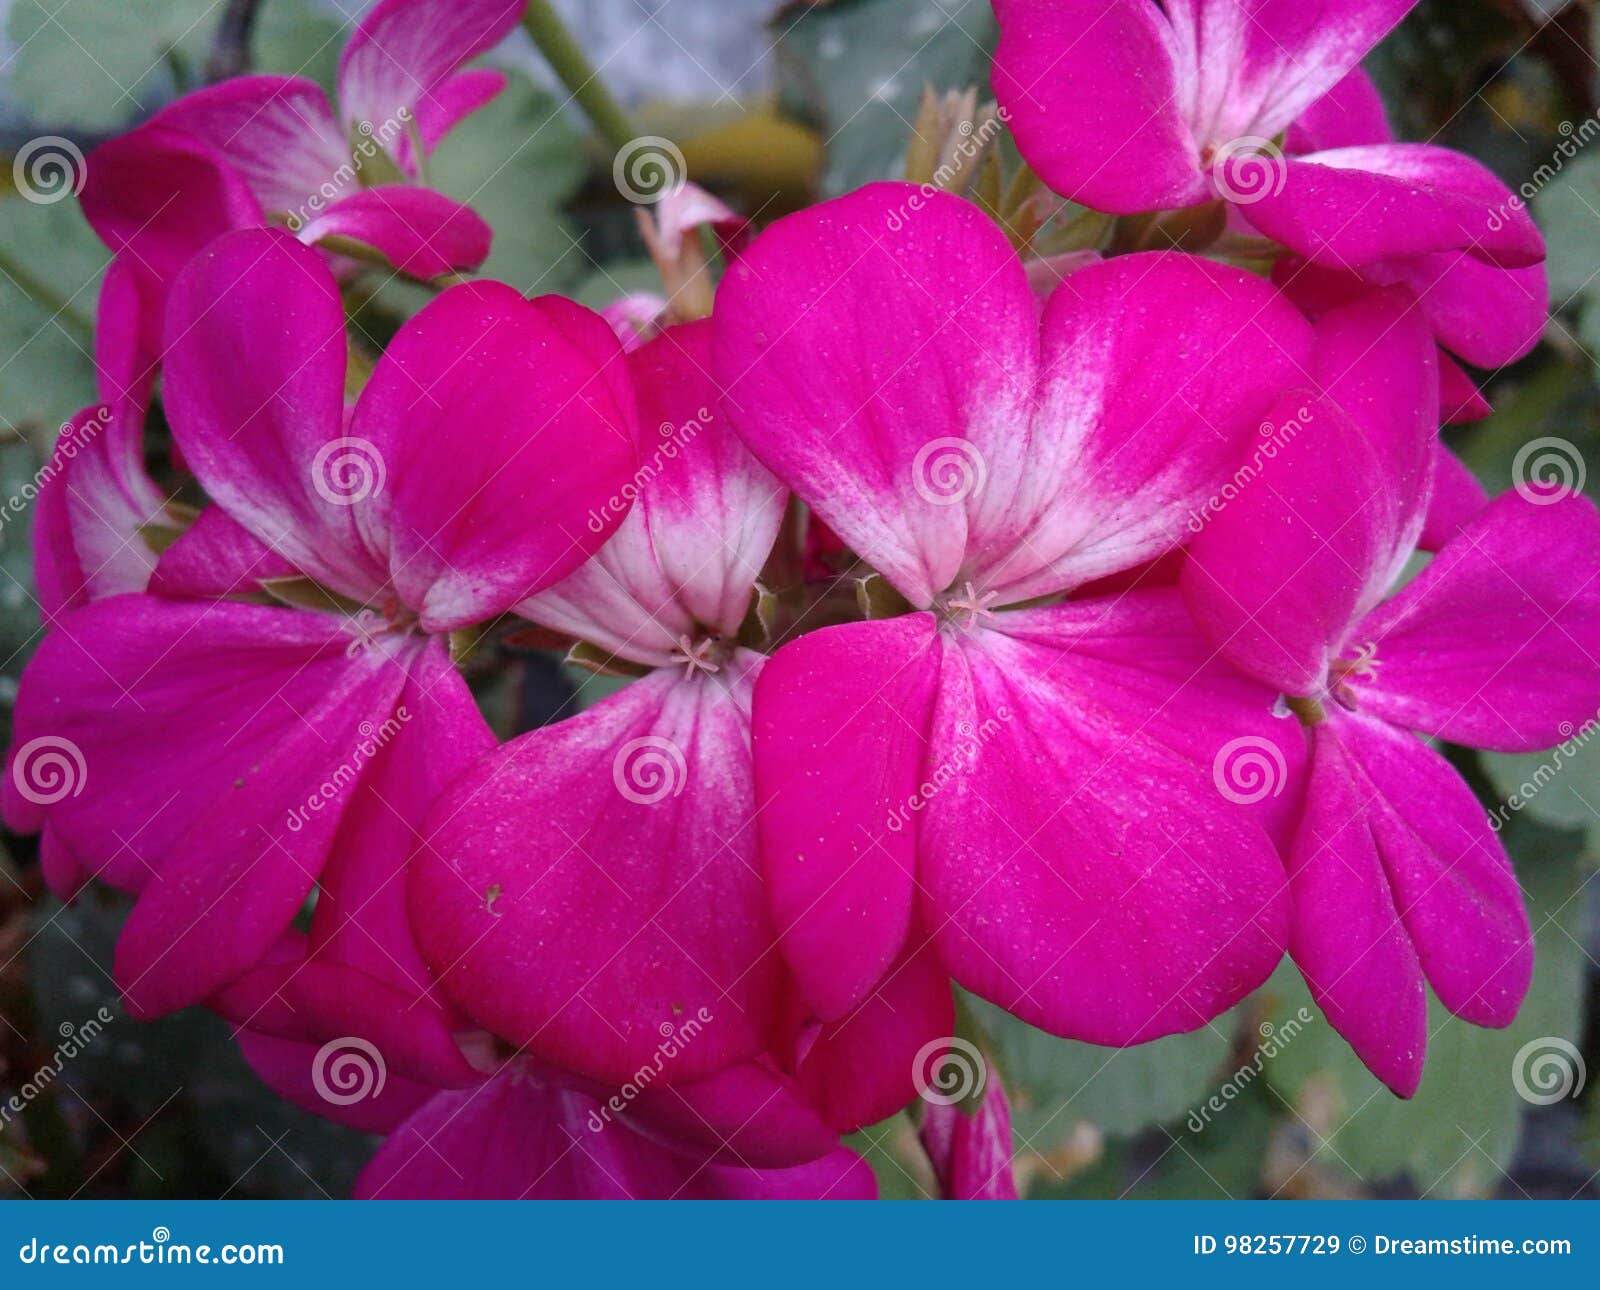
[714,184,1310,1044]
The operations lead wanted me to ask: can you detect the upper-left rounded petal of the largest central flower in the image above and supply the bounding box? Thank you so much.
[715,184,1037,607]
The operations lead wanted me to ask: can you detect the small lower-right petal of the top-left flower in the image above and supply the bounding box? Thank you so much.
[298,184,494,282]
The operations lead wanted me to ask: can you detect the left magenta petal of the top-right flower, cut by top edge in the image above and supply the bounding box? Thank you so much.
[994,0,1208,214]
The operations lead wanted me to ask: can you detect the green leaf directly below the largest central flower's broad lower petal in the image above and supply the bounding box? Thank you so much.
[963,996,1237,1152]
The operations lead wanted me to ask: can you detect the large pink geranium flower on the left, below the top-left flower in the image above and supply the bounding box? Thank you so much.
[6,230,637,1015]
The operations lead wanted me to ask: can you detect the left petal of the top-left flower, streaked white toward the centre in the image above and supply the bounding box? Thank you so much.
[154,77,347,222]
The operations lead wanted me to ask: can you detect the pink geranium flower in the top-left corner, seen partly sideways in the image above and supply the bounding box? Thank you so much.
[82,0,523,348]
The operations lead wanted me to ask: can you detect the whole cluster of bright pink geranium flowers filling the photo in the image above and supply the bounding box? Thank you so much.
[5,0,1600,1197]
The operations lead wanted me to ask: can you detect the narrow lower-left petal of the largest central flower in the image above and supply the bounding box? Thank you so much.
[754,615,938,1020]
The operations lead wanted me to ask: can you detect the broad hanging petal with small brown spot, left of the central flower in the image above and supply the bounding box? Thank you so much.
[411,653,781,1084]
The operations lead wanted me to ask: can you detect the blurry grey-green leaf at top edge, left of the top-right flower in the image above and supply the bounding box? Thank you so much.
[774,0,997,194]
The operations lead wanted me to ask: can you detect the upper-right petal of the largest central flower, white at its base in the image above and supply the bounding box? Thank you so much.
[968,253,1310,603]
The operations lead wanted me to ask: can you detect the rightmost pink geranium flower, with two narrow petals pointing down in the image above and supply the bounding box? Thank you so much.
[1182,289,1600,1096]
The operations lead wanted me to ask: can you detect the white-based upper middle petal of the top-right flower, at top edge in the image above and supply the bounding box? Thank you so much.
[1166,0,1416,147]
